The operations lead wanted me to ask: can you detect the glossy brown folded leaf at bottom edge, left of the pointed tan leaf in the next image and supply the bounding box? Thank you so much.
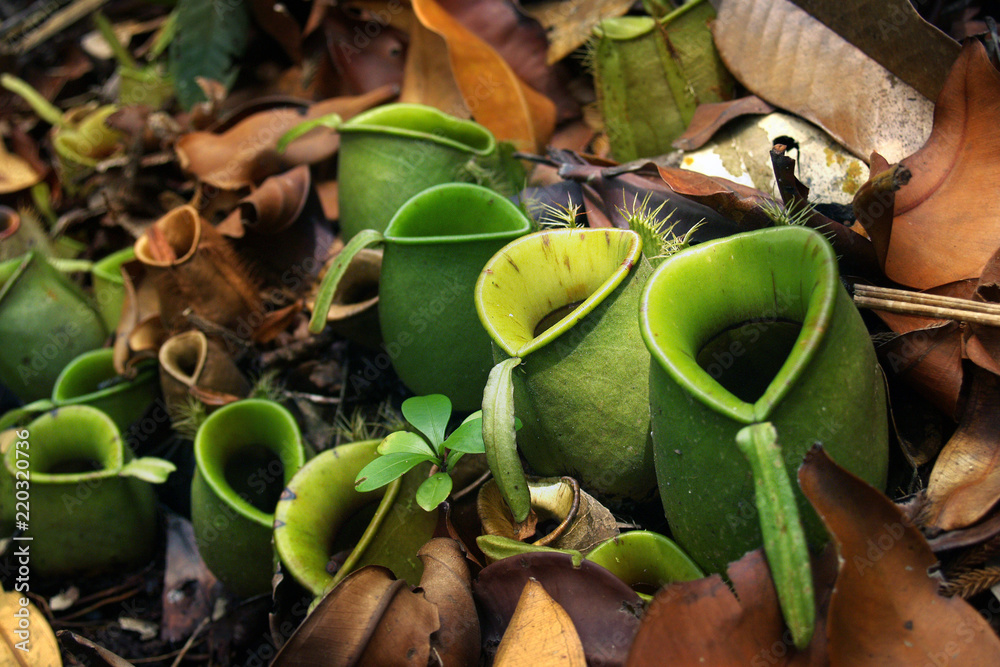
[271,565,439,667]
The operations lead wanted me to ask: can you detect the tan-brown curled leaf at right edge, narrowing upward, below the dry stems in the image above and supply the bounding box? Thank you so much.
[921,368,1000,530]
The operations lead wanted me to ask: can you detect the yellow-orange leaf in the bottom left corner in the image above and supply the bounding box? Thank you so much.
[0,588,62,667]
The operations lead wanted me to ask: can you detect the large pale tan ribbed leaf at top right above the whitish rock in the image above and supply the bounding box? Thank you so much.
[712,0,933,161]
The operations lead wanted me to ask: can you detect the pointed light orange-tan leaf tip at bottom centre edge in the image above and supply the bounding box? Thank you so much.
[493,579,587,667]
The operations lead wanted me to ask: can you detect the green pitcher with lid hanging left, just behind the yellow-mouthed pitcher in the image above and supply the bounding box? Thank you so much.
[310,183,531,410]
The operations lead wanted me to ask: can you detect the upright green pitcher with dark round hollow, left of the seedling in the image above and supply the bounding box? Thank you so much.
[191,399,305,596]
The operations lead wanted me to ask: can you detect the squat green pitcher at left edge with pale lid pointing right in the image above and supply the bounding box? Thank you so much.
[0,405,174,576]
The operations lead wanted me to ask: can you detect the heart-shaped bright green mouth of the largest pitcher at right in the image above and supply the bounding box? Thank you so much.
[640,227,839,424]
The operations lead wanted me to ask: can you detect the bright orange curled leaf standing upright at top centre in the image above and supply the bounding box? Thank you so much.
[413,0,556,151]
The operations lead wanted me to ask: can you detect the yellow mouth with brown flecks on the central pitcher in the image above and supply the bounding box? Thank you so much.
[475,229,642,358]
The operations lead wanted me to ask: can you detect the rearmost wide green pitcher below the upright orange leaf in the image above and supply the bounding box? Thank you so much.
[337,104,497,242]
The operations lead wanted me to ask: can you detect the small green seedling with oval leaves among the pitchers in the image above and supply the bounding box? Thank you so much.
[354,394,520,512]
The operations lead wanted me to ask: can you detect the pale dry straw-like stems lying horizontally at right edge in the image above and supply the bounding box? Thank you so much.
[854,285,1000,327]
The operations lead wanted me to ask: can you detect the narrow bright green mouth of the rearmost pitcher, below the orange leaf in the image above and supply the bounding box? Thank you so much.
[338,103,496,156]
